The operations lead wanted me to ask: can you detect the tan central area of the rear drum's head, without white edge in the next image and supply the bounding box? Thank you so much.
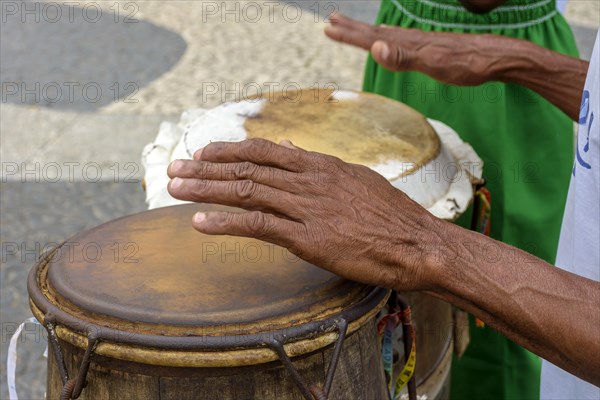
[244,89,440,180]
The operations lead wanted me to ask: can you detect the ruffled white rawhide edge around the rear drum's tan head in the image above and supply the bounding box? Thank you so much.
[142,101,483,220]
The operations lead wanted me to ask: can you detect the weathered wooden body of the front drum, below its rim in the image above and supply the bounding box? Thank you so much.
[47,321,386,400]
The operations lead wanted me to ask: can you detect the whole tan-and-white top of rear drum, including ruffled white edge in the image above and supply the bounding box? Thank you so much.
[142,89,483,220]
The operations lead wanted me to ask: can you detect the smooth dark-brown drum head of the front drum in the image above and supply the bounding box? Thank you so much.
[42,205,370,336]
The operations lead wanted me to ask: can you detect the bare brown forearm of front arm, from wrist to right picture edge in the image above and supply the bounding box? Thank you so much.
[424,223,600,385]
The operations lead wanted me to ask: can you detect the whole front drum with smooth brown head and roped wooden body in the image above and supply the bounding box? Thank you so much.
[28,204,388,400]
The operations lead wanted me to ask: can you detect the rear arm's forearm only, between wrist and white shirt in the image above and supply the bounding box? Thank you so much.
[495,39,589,121]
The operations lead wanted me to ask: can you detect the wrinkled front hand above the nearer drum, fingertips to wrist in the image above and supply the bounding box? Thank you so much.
[168,139,443,290]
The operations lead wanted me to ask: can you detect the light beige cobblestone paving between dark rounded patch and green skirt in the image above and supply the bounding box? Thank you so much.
[102,1,368,114]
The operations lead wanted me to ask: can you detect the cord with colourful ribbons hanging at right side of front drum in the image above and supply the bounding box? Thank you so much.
[377,291,417,400]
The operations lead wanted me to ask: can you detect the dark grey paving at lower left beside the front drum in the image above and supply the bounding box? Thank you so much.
[0,182,146,399]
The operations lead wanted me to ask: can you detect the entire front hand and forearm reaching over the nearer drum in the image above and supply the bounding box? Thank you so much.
[169,139,600,385]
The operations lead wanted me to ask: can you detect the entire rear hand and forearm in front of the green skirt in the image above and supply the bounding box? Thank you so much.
[325,13,588,120]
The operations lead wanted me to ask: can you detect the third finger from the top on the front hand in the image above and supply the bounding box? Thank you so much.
[167,178,299,218]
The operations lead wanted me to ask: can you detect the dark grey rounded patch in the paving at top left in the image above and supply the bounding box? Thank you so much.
[0,1,186,111]
